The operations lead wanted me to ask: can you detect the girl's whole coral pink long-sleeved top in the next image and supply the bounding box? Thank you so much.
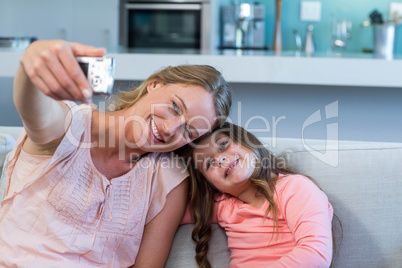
[217,175,333,268]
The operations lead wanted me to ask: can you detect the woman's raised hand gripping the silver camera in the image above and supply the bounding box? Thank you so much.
[20,40,105,102]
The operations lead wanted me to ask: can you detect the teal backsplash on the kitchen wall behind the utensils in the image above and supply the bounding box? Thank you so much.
[258,0,402,54]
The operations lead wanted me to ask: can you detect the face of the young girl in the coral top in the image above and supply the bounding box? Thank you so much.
[193,134,257,197]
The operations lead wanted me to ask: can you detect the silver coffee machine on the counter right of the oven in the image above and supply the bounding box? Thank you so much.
[221,2,267,49]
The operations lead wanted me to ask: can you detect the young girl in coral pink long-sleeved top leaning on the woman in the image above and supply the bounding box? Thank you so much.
[181,123,333,268]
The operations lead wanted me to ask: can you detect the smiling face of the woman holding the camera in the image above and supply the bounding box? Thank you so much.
[127,82,216,152]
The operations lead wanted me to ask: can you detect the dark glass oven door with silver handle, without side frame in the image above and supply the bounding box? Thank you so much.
[121,3,202,49]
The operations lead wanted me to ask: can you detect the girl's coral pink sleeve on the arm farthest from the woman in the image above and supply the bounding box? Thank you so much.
[268,176,333,268]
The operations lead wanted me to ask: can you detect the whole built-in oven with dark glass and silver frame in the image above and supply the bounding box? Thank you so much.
[119,0,210,49]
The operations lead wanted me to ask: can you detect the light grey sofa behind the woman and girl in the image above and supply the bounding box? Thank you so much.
[0,127,402,268]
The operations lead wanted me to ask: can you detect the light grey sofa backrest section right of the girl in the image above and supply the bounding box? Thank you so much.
[270,141,402,267]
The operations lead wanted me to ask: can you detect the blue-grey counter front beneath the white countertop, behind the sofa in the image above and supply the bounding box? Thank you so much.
[0,78,402,142]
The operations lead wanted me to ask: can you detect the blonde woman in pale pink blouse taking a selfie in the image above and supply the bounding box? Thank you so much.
[0,40,231,267]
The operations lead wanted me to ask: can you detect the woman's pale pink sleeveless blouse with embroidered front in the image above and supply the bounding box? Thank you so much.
[0,102,188,268]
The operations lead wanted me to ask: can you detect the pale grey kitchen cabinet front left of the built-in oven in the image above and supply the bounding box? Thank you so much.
[0,0,119,47]
